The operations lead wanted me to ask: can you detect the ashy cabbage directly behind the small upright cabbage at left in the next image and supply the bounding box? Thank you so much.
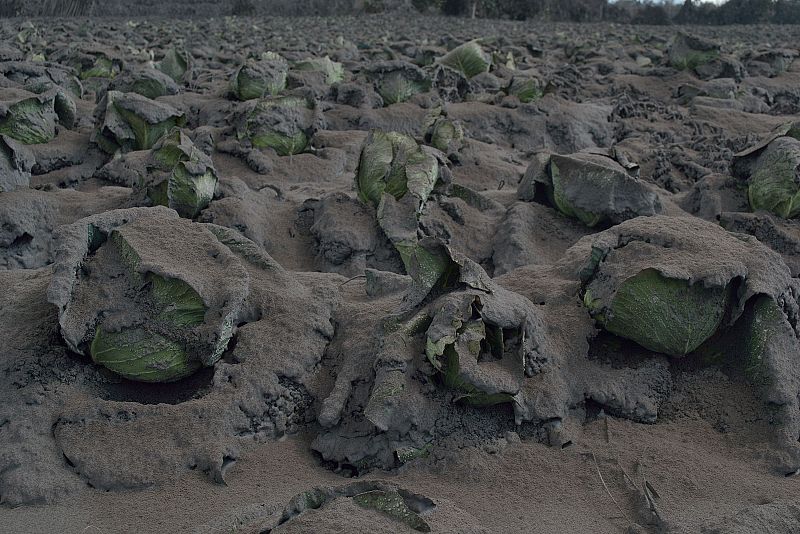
[93,91,186,154]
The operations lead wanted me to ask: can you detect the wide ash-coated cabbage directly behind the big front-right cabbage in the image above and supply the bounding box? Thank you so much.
[517,151,661,227]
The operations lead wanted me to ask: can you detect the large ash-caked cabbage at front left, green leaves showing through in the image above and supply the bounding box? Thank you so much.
[48,207,248,382]
